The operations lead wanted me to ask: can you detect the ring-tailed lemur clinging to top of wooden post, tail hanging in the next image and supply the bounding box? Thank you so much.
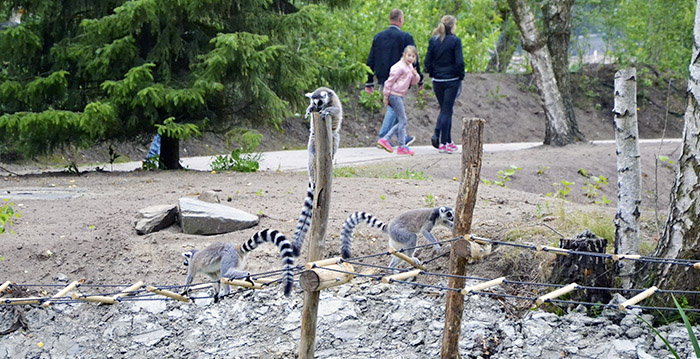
[292,87,343,251]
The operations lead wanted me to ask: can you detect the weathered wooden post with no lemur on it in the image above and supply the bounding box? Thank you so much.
[440,118,484,359]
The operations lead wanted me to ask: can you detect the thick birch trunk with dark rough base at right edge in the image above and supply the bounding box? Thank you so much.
[639,0,700,305]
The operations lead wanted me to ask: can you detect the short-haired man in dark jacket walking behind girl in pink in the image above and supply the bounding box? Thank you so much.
[365,9,423,146]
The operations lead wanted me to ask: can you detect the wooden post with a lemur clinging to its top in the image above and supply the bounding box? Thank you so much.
[299,112,333,359]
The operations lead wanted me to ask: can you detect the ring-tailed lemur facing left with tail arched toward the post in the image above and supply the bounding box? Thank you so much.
[182,229,299,302]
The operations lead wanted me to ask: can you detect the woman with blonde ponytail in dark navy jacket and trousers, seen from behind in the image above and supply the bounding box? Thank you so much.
[423,15,464,153]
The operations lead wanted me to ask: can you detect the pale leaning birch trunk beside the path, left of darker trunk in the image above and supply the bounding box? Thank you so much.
[508,0,584,146]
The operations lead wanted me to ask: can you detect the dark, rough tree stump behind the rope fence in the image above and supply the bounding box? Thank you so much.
[550,229,612,303]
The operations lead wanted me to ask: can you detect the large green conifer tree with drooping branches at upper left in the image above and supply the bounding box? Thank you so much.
[0,0,364,168]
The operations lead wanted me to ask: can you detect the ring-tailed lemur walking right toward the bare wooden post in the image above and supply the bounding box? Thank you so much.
[340,206,455,268]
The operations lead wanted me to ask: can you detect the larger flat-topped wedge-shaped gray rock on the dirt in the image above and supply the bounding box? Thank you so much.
[179,198,260,234]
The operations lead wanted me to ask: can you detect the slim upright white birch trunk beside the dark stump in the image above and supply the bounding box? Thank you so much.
[613,68,642,288]
